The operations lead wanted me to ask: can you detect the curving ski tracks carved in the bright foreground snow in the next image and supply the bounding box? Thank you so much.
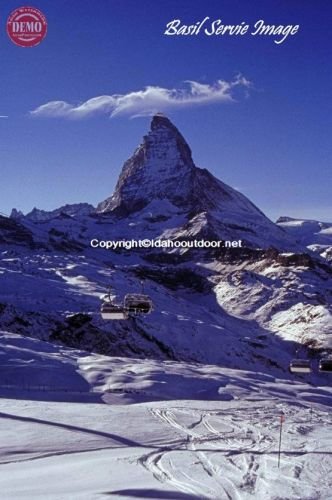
[141,408,273,500]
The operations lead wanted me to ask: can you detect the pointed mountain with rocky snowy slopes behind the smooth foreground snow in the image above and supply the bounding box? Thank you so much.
[0,115,332,374]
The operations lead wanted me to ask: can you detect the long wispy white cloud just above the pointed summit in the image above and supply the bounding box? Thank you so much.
[30,75,251,118]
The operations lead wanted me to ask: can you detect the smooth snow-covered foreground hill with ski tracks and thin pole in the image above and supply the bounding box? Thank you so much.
[0,333,332,500]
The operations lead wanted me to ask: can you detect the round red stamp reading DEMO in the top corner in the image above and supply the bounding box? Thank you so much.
[7,7,47,47]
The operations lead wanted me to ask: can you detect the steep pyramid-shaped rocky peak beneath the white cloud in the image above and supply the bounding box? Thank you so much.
[97,113,270,221]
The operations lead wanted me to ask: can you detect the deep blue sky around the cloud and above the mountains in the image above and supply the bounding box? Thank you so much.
[0,0,332,220]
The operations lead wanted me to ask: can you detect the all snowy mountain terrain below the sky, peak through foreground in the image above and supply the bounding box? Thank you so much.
[0,115,332,500]
